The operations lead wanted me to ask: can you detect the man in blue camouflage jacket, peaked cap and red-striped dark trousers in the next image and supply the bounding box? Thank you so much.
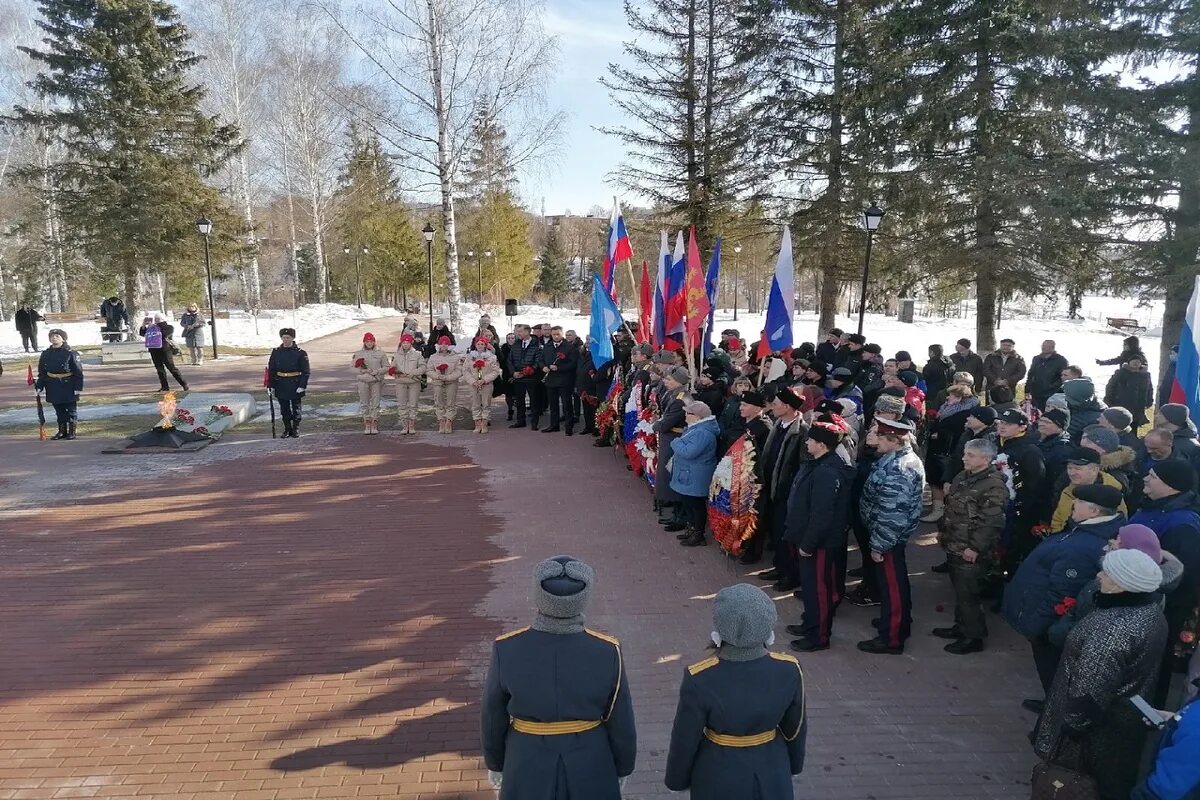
[858,420,925,655]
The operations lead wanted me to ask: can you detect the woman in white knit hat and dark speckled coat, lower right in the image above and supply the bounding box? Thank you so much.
[1033,549,1166,800]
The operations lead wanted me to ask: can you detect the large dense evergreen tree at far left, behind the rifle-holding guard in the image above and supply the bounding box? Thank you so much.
[13,0,244,316]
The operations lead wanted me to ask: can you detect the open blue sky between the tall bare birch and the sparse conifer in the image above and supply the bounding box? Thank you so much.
[523,0,635,213]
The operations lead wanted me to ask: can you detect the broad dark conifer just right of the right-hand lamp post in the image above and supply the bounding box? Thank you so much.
[869,0,1093,350]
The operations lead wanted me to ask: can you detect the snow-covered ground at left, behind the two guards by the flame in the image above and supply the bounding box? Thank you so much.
[0,303,400,355]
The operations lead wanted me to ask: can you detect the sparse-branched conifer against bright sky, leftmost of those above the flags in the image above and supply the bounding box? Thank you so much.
[601,0,756,248]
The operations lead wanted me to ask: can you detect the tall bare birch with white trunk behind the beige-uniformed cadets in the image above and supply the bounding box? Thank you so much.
[323,0,563,330]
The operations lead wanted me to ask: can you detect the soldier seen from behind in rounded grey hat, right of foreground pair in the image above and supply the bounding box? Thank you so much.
[666,583,808,800]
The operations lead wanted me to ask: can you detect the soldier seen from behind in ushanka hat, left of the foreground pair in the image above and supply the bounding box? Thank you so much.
[481,555,637,800]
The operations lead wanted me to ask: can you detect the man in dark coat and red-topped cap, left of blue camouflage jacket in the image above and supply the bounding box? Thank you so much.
[782,421,854,652]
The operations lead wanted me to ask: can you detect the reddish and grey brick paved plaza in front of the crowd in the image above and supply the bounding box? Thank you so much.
[0,321,1037,800]
